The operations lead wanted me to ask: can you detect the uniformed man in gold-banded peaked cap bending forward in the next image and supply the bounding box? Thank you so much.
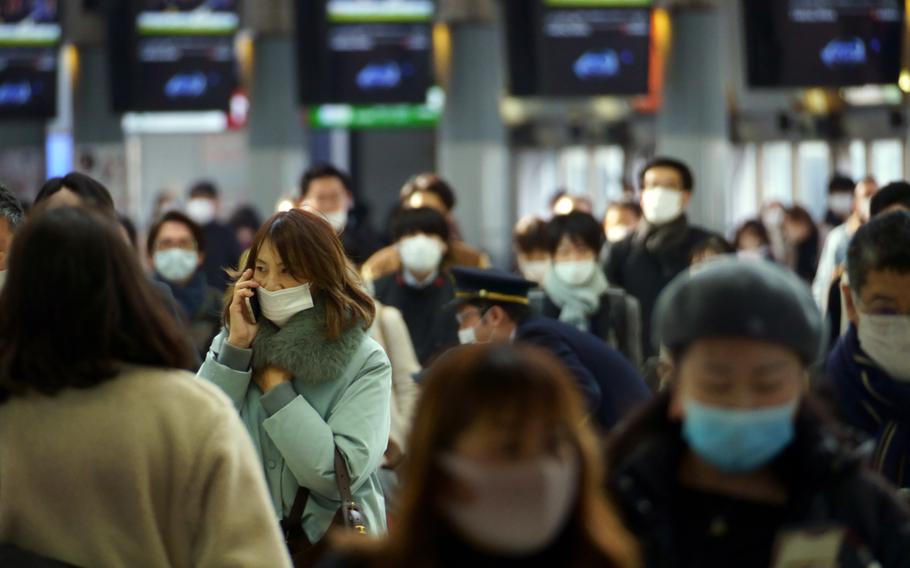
[452,267,651,431]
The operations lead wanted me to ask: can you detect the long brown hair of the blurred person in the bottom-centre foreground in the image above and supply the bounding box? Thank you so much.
[336,345,640,568]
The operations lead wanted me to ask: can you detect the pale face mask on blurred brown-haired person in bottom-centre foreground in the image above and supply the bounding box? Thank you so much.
[442,455,579,556]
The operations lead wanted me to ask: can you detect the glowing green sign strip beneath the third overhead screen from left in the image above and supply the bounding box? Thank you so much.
[309,104,442,130]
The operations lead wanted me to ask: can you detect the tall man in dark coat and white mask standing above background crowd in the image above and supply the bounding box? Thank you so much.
[606,158,711,358]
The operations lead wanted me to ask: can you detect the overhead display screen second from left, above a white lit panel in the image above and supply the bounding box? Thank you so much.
[112,0,240,111]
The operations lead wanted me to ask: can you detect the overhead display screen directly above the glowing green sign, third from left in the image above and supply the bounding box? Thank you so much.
[298,0,434,104]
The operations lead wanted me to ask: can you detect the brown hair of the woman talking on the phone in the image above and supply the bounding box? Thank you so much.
[223,209,376,341]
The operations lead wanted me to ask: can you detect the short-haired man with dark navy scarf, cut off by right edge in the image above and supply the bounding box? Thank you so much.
[827,211,910,491]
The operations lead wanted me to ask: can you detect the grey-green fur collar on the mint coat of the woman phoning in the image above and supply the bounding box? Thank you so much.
[253,299,366,385]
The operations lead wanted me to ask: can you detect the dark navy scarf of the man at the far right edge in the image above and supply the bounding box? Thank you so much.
[828,326,910,487]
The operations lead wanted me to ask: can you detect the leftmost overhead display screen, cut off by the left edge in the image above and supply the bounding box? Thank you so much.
[0,0,61,118]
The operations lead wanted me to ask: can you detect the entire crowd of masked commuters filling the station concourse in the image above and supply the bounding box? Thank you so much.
[0,157,910,568]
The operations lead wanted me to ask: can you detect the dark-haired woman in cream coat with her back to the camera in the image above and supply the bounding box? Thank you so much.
[0,207,288,567]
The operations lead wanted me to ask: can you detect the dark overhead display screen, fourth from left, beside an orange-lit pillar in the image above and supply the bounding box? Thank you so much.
[506,0,651,97]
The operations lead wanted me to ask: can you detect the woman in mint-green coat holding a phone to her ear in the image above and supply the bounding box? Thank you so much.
[198,209,392,560]
